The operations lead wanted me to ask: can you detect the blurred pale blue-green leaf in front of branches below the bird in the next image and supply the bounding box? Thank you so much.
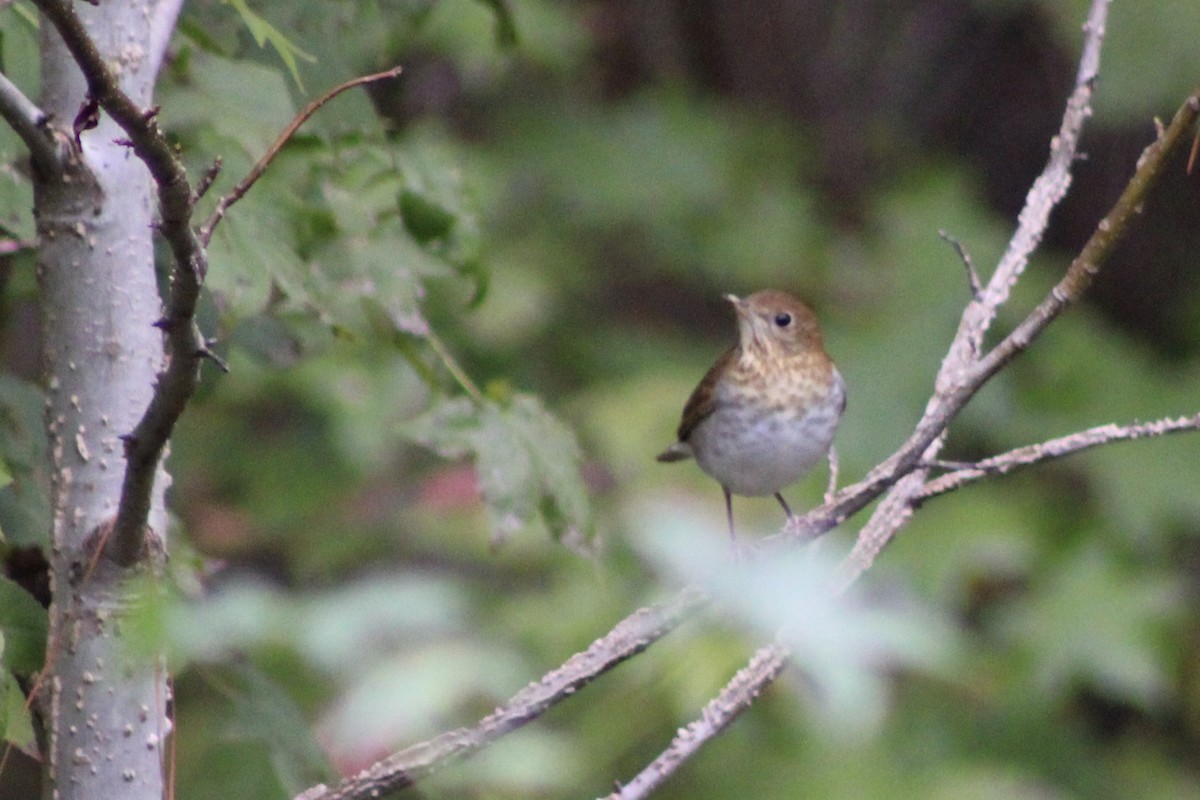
[630,504,962,738]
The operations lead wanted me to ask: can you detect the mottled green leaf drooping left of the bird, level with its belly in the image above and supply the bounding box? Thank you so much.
[401,395,592,546]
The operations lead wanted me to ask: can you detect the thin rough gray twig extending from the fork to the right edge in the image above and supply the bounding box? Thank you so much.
[917,414,1200,504]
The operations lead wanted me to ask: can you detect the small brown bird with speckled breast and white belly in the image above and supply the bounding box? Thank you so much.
[659,289,846,542]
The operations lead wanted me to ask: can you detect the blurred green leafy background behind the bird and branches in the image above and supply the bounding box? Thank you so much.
[0,0,1200,799]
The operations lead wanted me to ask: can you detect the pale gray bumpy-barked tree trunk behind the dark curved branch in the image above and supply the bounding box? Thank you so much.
[35,0,180,800]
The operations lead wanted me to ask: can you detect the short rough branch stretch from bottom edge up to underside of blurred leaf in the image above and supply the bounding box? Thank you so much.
[605,643,788,800]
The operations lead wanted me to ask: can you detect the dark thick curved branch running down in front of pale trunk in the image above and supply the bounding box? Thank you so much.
[34,0,208,565]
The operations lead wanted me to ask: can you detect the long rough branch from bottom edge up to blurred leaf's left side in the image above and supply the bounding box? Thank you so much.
[296,589,708,800]
